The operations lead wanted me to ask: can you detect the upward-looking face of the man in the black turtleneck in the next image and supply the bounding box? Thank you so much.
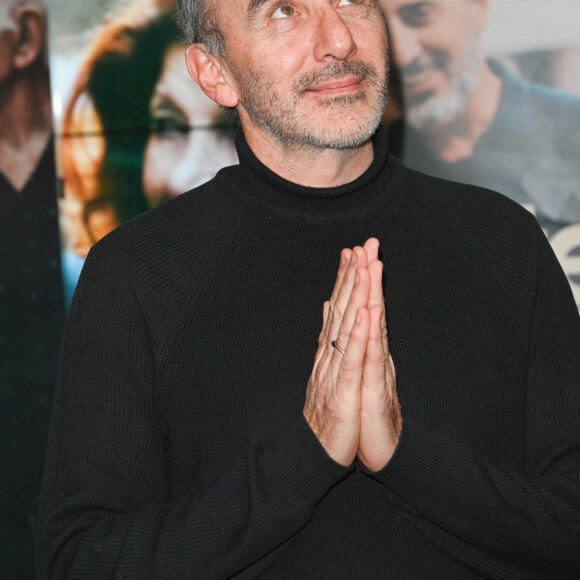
[209,0,387,149]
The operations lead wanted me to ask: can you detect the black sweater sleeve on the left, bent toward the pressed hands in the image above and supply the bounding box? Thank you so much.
[37,246,349,579]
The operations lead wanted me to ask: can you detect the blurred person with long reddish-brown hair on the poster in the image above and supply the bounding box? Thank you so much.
[62,0,237,302]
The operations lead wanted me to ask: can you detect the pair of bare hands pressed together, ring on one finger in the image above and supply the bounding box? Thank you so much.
[304,238,402,471]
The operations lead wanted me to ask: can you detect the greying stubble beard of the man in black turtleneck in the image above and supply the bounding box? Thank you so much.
[234,56,388,150]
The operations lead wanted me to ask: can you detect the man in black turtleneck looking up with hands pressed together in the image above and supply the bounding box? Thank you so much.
[38,0,580,578]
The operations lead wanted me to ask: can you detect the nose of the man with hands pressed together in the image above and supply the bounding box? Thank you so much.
[314,6,356,61]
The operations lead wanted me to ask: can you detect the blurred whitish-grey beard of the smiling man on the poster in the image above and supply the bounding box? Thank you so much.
[405,42,482,130]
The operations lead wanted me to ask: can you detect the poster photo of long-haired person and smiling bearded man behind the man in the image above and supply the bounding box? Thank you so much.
[51,0,580,305]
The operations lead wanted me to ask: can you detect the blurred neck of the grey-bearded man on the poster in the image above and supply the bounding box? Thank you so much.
[421,62,502,163]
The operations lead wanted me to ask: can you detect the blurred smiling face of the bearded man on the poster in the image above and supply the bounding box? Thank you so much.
[379,0,487,129]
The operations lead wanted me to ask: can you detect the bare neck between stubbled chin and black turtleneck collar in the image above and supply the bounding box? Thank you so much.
[242,119,374,188]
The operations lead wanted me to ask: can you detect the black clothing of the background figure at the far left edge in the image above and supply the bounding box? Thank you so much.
[0,137,64,579]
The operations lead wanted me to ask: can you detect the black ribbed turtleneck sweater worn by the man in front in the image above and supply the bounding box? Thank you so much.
[38,129,580,579]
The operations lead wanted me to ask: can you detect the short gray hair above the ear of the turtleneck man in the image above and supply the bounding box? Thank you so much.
[175,0,226,56]
